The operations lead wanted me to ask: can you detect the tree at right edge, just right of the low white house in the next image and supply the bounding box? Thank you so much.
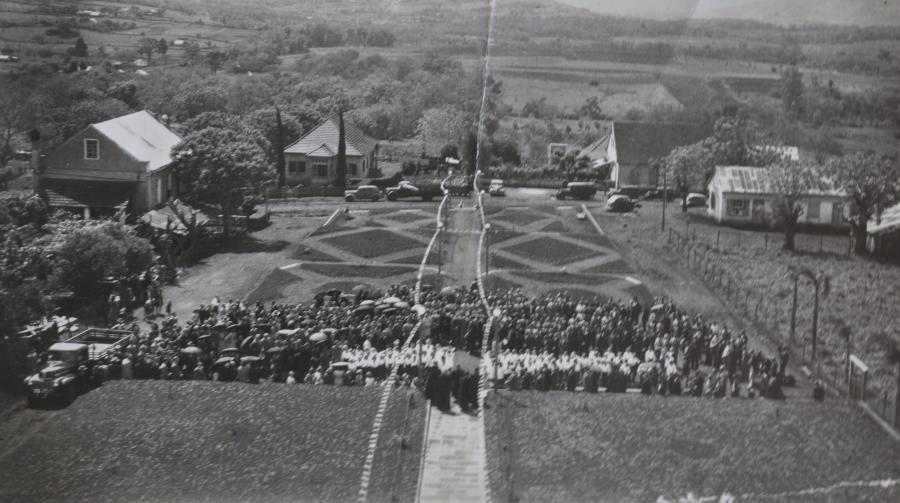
[826,152,900,255]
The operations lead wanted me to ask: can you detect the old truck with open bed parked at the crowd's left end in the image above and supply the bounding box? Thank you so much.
[25,328,131,407]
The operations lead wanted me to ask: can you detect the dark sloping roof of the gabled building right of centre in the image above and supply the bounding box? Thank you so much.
[613,122,712,164]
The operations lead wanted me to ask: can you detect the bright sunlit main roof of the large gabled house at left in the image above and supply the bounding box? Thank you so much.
[94,110,181,172]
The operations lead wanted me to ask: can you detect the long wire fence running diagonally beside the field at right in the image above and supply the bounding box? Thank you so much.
[668,226,900,428]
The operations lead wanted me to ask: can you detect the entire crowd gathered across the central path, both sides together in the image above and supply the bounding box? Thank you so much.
[33,285,788,410]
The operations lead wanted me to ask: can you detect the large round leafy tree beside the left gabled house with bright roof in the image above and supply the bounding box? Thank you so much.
[172,127,270,239]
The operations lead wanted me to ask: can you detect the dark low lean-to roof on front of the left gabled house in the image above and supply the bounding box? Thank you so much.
[38,178,137,208]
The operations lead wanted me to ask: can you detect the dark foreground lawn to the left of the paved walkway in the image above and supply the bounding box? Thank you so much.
[0,381,390,502]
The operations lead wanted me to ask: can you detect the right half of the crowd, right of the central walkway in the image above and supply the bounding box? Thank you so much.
[490,292,788,398]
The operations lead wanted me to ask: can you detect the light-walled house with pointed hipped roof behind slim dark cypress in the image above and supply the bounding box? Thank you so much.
[284,116,378,186]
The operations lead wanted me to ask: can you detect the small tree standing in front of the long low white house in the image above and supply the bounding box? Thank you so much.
[764,160,818,251]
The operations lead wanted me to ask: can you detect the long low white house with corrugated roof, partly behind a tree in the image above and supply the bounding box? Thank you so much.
[706,166,847,227]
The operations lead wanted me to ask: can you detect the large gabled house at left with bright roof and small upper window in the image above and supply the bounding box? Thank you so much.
[34,111,181,218]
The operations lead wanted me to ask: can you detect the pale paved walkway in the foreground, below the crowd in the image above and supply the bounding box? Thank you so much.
[419,409,487,503]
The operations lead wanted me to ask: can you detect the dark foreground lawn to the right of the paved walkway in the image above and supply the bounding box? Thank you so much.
[486,392,900,502]
